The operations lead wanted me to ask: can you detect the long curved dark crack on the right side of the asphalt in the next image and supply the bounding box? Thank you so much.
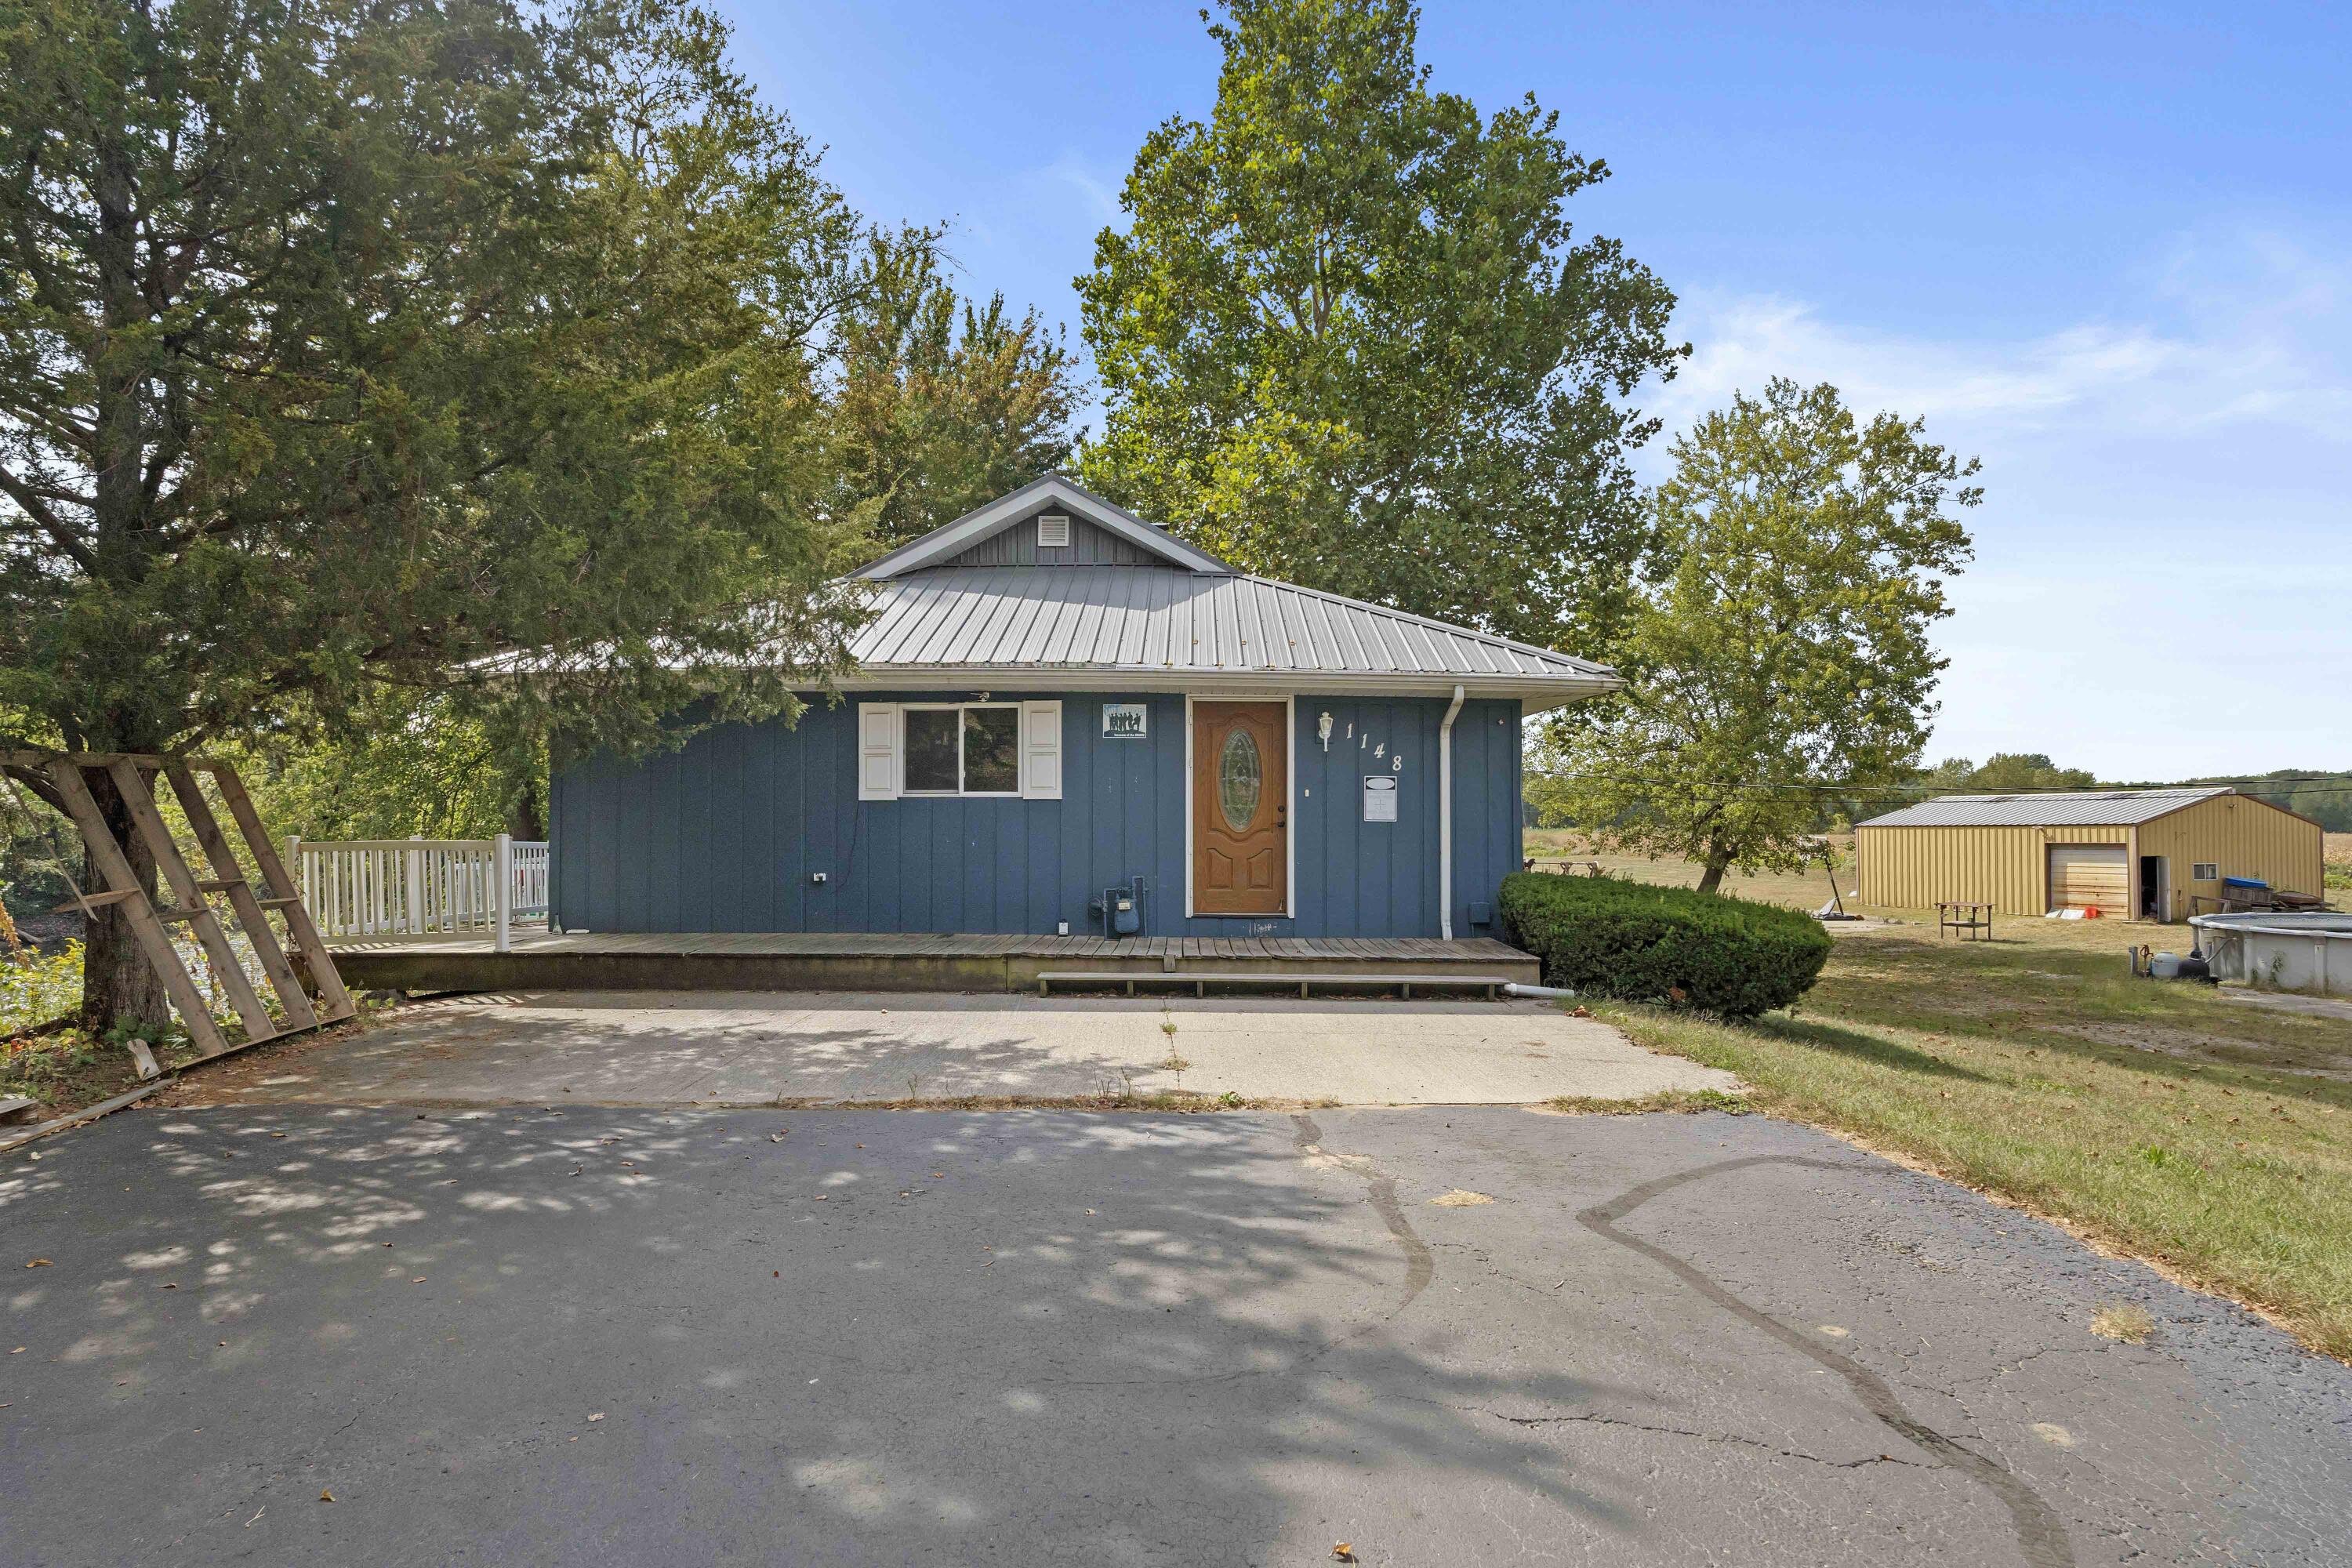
[1576,1154,2074,1568]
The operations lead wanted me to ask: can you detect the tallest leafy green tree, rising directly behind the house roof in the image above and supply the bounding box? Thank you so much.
[1077,0,1686,649]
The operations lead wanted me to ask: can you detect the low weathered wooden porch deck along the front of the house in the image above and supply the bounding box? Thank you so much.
[334,931,1541,992]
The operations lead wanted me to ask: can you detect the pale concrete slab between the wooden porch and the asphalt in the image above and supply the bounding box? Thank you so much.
[170,992,1736,1105]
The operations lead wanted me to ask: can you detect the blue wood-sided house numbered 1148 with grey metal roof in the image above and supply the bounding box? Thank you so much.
[550,475,1618,938]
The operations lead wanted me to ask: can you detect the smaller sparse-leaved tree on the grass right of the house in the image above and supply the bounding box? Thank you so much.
[1536,379,1983,891]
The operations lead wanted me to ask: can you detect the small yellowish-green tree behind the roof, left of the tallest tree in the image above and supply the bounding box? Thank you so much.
[830,230,1080,548]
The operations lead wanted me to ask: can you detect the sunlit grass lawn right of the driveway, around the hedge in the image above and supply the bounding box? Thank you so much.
[1529,832,2352,1361]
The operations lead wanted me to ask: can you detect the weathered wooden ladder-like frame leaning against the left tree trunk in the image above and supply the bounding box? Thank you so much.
[0,753,355,1079]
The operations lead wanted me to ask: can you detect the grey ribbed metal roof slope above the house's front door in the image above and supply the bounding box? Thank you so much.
[849,567,1623,701]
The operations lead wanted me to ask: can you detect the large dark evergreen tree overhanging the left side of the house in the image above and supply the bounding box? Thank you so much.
[0,0,861,1025]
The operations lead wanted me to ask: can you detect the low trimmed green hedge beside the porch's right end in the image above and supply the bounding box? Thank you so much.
[1503,872,1830,1018]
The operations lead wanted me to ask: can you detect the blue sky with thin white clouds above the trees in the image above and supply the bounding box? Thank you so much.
[731,0,2352,779]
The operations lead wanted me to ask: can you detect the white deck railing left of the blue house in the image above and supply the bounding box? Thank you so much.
[287,832,548,952]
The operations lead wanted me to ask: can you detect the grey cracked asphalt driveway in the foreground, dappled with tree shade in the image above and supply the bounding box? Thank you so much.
[0,1105,2352,1568]
